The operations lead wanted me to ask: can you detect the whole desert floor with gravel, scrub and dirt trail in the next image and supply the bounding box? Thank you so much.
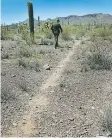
[1,21,112,137]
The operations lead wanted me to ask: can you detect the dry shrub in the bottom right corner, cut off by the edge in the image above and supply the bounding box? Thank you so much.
[102,106,112,137]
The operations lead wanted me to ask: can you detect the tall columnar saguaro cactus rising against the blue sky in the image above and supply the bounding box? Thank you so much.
[27,2,34,39]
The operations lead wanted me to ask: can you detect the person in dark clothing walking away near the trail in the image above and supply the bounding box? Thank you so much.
[51,19,63,49]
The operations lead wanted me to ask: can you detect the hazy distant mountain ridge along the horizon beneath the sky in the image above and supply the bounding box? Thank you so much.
[21,13,112,25]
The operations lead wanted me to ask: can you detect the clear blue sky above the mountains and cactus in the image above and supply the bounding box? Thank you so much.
[1,0,112,24]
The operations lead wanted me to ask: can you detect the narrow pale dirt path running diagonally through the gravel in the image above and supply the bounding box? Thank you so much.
[7,40,81,136]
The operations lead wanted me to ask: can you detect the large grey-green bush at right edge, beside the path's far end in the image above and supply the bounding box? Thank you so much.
[82,41,112,70]
